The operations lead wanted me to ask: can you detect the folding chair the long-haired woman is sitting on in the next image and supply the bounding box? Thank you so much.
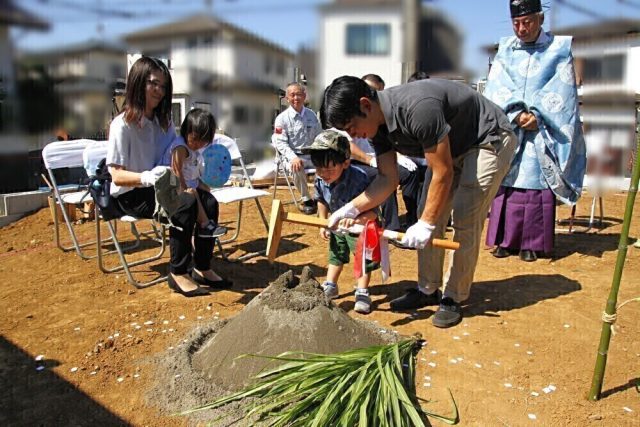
[83,141,167,289]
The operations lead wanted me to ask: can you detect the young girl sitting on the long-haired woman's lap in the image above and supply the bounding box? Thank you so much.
[171,108,227,238]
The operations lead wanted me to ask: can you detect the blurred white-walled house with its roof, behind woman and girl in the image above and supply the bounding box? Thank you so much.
[124,15,294,160]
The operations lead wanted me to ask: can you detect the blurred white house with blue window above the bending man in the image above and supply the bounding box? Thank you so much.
[318,0,462,88]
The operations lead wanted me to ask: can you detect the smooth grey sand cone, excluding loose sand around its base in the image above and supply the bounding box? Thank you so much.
[192,267,388,390]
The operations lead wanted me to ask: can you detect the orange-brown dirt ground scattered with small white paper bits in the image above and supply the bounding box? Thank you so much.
[0,191,640,426]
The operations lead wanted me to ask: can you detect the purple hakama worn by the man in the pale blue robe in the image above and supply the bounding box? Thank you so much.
[487,187,556,254]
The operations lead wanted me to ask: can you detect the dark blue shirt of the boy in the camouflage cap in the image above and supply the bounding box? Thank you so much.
[313,165,369,212]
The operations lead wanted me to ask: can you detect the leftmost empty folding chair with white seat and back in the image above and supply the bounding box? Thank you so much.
[42,139,101,259]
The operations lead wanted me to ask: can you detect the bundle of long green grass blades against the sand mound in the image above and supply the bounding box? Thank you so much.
[182,339,458,427]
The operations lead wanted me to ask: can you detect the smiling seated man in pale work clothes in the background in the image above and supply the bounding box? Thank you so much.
[272,82,322,215]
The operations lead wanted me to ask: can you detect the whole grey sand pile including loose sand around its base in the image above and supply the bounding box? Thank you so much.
[146,268,398,425]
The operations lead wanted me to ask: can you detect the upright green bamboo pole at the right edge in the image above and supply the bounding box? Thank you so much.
[588,106,640,402]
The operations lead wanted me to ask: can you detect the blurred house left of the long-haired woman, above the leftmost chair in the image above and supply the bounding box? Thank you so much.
[21,40,127,139]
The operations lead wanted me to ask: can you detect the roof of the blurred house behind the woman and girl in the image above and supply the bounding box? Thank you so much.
[124,15,293,56]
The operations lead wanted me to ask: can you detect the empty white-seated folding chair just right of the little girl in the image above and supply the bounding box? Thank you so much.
[211,134,269,262]
